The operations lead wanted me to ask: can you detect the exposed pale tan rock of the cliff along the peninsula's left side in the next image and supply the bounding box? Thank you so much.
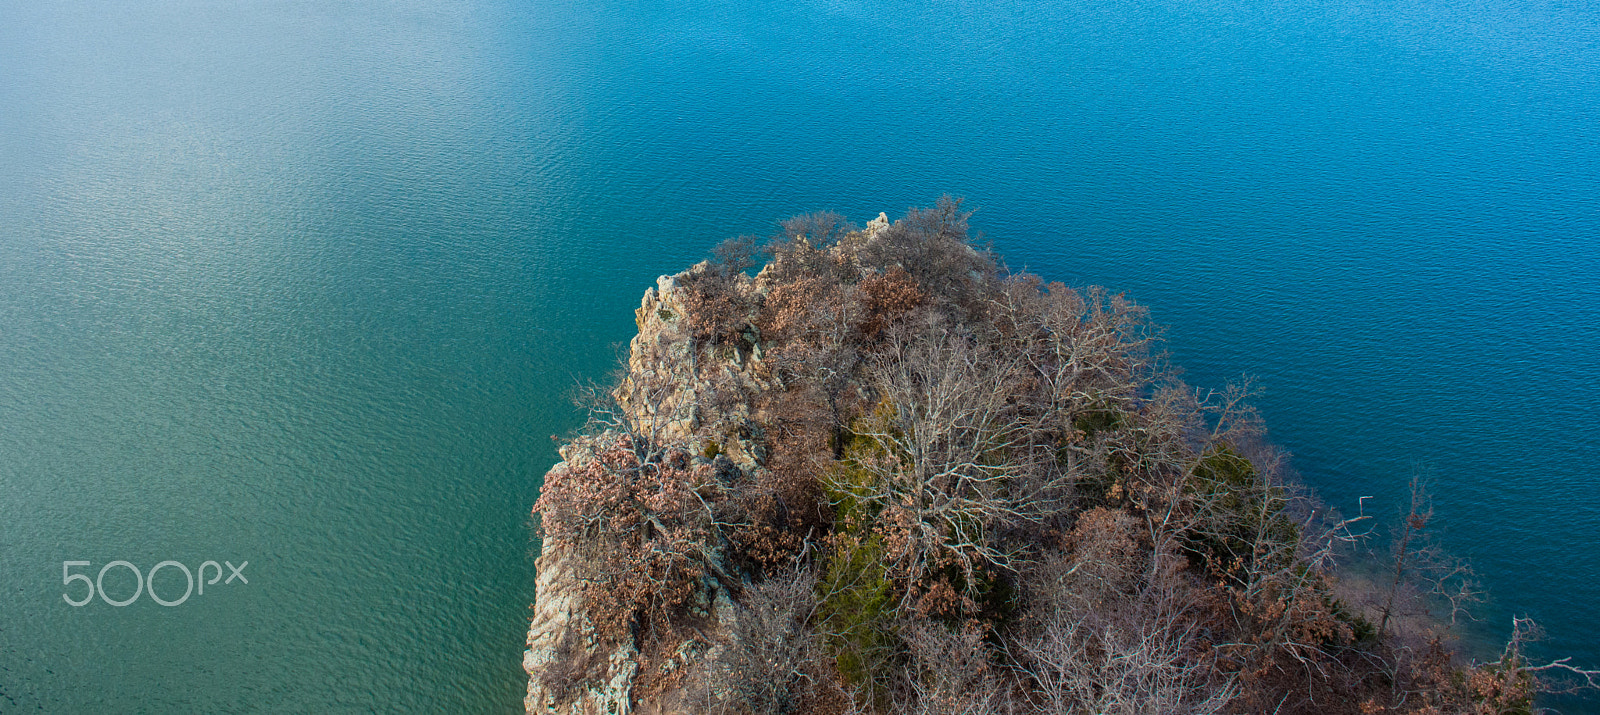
[523,214,915,715]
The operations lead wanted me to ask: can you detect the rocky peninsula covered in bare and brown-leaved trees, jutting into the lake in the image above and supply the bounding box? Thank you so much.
[523,198,1600,715]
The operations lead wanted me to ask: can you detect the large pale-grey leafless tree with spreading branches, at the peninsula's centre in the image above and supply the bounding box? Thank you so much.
[834,320,1066,593]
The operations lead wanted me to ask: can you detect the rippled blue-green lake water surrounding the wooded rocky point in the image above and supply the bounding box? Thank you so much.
[0,0,1600,712]
